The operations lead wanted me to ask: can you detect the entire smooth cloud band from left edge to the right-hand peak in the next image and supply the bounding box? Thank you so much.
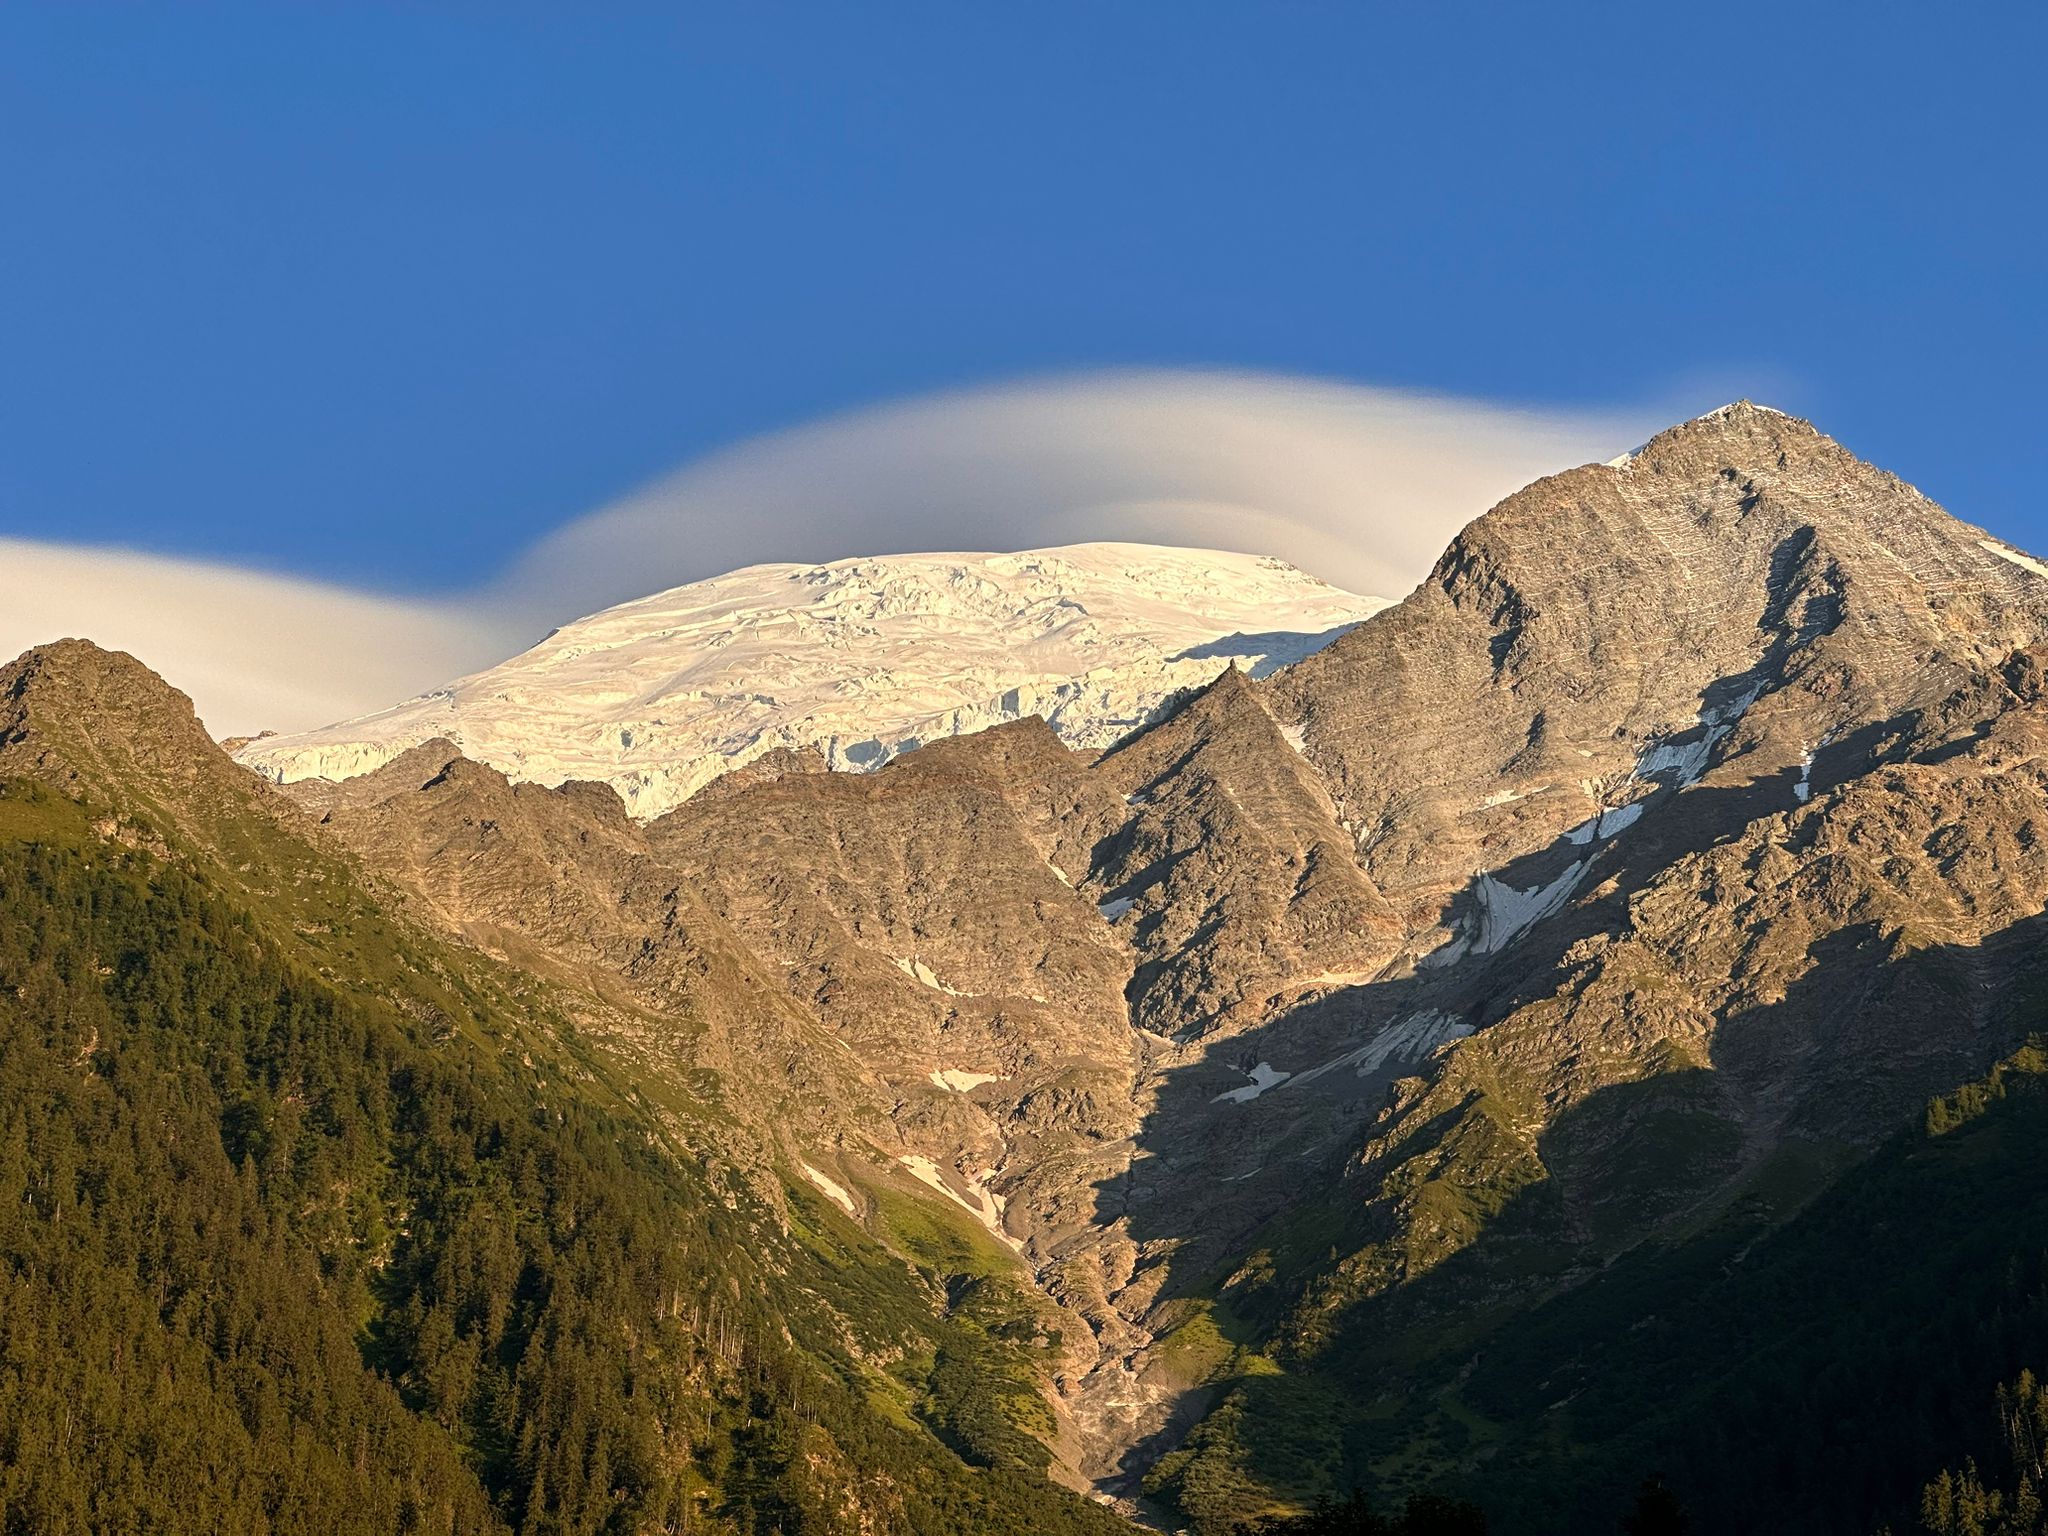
[0,371,1661,735]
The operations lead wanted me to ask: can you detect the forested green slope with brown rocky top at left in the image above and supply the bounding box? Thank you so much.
[0,643,1122,1536]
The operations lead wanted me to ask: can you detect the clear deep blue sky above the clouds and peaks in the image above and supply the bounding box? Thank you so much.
[0,0,2048,590]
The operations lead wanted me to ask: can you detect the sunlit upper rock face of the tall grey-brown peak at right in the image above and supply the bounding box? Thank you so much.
[1264,401,2048,926]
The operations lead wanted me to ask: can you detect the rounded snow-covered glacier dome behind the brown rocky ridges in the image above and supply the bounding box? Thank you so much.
[238,545,1386,819]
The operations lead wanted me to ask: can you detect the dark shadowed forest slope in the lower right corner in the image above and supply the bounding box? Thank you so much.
[1153,1044,2048,1536]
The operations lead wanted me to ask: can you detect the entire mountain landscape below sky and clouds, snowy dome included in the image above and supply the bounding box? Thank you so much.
[12,403,2048,1536]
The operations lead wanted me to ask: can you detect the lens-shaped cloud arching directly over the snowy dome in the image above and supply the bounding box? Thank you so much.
[498,371,1663,618]
